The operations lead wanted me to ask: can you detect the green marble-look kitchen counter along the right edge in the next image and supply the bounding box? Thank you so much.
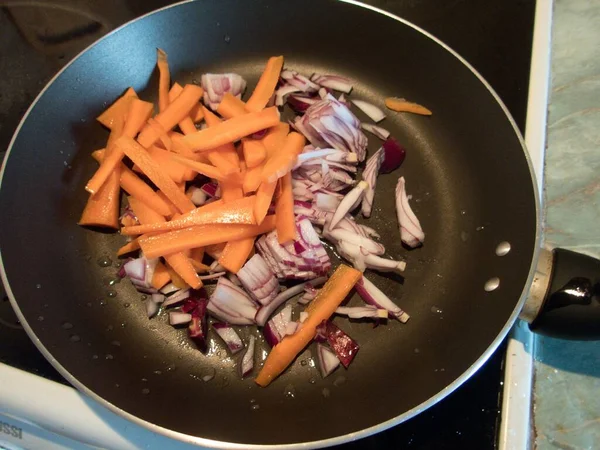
[534,0,600,450]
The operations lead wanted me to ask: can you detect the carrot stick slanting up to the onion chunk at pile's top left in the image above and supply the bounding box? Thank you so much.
[138,84,203,148]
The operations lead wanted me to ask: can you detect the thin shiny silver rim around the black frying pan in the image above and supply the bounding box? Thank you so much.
[0,0,542,450]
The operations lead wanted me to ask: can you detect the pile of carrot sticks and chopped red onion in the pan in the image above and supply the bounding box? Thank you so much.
[79,50,431,386]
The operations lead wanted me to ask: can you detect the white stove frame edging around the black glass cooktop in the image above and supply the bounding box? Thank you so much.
[0,0,552,450]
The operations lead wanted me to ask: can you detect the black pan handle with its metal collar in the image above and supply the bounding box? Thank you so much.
[521,248,600,340]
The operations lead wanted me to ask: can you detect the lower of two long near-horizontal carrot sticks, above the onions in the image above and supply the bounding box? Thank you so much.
[139,216,275,258]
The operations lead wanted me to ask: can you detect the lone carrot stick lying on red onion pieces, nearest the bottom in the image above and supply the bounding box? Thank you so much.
[254,264,362,387]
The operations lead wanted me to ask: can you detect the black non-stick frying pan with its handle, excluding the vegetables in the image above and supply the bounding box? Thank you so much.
[0,0,600,448]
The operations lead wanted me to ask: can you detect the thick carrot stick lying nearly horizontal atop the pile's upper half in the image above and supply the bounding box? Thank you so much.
[182,106,279,151]
